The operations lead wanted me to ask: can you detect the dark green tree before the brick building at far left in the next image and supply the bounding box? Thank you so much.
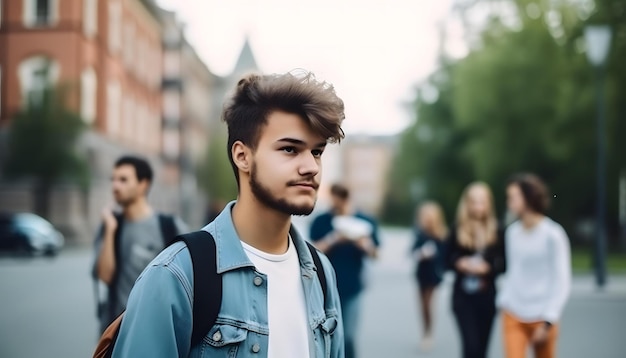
[4,87,89,217]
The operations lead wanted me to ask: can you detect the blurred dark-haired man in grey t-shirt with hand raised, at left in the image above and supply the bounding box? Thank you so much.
[93,156,186,331]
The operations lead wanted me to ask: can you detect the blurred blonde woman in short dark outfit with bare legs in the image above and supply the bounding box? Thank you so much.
[412,201,448,350]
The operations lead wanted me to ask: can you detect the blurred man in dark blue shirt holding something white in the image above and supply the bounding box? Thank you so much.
[310,184,379,358]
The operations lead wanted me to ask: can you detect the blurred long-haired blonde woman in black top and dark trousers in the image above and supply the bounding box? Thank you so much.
[448,182,505,358]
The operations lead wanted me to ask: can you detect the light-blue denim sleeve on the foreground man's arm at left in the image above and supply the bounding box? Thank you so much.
[113,265,192,358]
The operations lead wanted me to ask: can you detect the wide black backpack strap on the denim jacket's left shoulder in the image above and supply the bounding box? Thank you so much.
[173,230,222,347]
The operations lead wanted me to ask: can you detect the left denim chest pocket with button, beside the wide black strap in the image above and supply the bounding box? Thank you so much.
[200,324,248,358]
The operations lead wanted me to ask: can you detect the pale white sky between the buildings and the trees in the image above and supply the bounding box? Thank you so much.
[158,0,452,135]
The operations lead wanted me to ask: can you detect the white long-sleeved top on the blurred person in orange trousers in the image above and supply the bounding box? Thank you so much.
[498,218,572,322]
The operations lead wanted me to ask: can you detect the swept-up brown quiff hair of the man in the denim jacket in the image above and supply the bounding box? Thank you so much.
[222,72,345,185]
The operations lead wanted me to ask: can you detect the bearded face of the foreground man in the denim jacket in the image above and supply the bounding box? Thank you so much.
[249,111,326,215]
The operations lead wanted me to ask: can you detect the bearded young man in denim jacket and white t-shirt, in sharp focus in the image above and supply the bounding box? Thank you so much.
[113,74,344,358]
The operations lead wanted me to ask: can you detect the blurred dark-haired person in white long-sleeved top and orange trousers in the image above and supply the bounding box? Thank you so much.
[498,174,571,358]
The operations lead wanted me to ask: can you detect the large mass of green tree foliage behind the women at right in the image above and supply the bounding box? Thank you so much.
[386,0,626,243]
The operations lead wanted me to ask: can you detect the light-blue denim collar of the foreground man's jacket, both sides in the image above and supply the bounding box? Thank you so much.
[202,201,315,275]
